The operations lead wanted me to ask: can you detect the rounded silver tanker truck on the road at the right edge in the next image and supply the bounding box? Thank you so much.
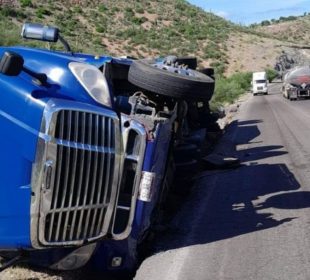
[282,66,310,100]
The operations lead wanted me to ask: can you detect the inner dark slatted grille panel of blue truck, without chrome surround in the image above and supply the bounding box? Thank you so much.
[45,110,115,242]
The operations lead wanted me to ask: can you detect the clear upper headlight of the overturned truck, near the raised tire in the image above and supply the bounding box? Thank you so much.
[69,62,112,107]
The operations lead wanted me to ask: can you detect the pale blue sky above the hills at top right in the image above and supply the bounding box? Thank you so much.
[189,0,310,25]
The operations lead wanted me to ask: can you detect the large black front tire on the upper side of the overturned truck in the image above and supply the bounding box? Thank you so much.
[128,60,214,101]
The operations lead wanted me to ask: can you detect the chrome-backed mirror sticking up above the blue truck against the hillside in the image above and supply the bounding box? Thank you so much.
[21,23,59,43]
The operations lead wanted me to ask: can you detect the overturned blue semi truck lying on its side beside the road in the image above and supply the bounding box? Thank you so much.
[0,24,214,272]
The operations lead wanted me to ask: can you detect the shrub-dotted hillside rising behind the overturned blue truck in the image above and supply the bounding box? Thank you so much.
[0,0,286,73]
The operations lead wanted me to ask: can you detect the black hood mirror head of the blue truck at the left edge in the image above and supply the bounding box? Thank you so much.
[0,51,24,76]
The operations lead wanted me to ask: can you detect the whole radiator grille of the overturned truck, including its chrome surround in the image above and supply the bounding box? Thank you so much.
[32,103,121,247]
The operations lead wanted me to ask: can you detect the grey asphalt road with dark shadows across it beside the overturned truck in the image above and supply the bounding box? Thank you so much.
[135,84,310,280]
